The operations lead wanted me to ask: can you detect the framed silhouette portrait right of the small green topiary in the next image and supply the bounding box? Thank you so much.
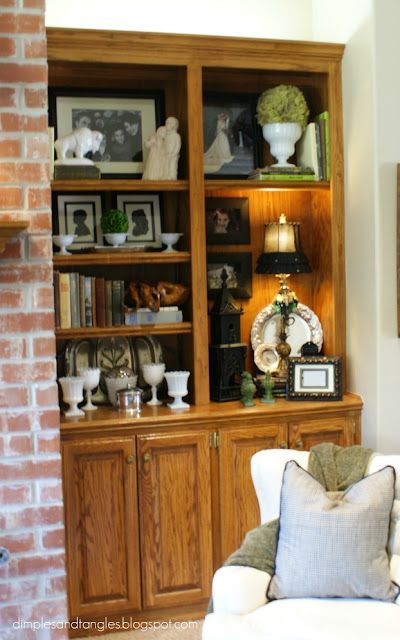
[116,193,162,248]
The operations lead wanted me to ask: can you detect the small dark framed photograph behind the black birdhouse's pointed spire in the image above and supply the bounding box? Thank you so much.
[207,252,252,298]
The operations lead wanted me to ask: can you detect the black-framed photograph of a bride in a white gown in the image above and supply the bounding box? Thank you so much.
[203,94,261,178]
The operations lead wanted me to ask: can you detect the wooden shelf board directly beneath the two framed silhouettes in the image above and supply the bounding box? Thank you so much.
[53,251,190,267]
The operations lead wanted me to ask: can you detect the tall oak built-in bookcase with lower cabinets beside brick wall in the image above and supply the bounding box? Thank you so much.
[47,28,361,632]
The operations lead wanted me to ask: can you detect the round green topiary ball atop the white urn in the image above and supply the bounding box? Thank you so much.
[257,84,310,131]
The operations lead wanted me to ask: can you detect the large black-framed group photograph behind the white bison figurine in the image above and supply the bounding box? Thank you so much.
[50,90,161,177]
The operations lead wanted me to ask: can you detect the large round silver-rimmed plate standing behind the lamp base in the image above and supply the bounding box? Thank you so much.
[250,303,323,358]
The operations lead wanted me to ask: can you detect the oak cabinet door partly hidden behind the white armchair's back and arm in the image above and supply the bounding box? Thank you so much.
[219,423,287,561]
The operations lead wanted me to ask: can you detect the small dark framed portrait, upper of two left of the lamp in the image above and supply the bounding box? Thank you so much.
[206,198,250,244]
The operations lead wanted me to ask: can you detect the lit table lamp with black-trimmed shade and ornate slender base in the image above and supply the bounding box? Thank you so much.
[256,213,311,378]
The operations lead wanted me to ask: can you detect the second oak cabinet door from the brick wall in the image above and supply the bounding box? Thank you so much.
[138,431,212,608]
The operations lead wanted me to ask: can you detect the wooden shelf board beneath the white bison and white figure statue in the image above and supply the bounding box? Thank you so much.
[51,178,189,192]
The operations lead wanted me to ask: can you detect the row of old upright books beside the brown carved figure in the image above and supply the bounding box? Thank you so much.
[54,271,125,329]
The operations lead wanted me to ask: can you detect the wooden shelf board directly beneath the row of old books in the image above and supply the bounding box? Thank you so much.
[56,322,192,340]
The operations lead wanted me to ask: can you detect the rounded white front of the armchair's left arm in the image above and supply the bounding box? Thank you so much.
[212,566,271,615]
